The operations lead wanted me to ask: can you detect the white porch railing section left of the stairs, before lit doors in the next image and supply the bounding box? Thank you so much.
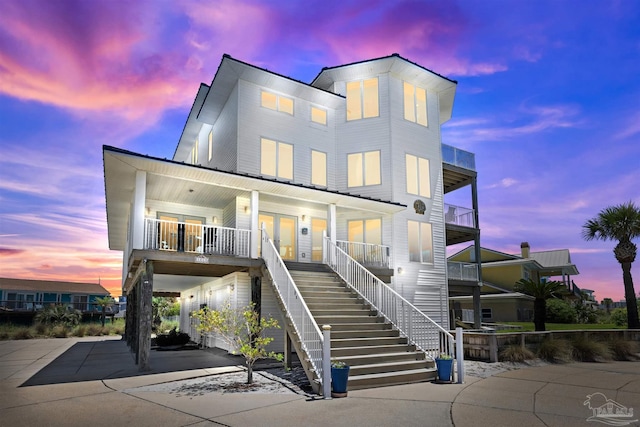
[144,218,251,258]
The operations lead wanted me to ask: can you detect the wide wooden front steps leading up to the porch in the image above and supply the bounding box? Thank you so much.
[288,263,436,390]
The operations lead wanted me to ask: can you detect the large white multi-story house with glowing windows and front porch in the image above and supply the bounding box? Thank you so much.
[103,54,480,392]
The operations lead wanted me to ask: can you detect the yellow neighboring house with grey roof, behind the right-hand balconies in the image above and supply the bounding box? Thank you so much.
[449,242,581,322]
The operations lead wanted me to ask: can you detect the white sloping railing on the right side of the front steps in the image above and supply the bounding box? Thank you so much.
[323,237,455,359]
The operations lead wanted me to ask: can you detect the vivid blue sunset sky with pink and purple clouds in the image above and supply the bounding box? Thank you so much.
[0,0,640,300]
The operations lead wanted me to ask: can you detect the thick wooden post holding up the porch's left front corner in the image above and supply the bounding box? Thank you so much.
[137,259,153,371]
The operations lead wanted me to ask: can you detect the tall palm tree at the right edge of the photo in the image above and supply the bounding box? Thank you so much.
[582,202,640,329]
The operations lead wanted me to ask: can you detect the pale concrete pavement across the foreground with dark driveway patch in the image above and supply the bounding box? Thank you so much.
[0,337,640,427]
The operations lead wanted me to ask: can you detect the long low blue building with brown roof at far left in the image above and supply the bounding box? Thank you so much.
[0,277,109,312]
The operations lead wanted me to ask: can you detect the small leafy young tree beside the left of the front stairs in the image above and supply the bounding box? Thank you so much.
[191,302,282,384]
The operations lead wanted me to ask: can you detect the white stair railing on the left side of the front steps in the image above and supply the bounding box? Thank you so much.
[262,228,330,388]
